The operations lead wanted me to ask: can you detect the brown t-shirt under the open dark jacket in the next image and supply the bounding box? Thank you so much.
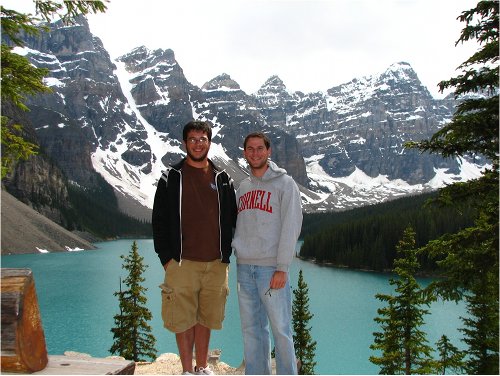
[181,163,221,261]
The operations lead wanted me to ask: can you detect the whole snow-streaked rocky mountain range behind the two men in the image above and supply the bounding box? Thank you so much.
[5,17,482,217]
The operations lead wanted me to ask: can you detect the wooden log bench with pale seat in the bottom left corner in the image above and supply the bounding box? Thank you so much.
[0,268,135,375]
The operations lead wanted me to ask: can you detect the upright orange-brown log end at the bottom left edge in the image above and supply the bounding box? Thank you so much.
[1,268,48,373]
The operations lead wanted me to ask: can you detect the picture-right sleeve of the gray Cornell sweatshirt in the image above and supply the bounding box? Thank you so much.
[277,175,302,272]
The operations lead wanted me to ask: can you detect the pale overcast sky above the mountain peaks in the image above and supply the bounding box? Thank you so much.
[4,0,477,98]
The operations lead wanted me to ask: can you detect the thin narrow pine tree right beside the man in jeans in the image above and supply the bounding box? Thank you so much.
[292,270,316,375]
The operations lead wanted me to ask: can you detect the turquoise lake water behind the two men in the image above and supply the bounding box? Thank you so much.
[1,239,465,375]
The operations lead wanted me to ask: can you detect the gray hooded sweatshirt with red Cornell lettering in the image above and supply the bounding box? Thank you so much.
[232,161,302,272]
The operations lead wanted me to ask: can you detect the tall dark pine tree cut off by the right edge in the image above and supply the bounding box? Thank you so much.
[409,0,499,374]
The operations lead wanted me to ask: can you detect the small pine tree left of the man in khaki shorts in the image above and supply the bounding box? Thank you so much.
[109,241,156,362]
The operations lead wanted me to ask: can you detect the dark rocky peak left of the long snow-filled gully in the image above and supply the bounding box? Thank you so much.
[20,17,148,186]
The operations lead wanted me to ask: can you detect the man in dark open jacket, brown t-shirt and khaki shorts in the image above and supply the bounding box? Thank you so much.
[152,121,237,375]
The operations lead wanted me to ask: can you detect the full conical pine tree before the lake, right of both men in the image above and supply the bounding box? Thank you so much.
[370,227,433,375]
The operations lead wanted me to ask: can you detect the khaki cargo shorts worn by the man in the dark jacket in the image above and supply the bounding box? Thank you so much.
[160,259,229,333]
